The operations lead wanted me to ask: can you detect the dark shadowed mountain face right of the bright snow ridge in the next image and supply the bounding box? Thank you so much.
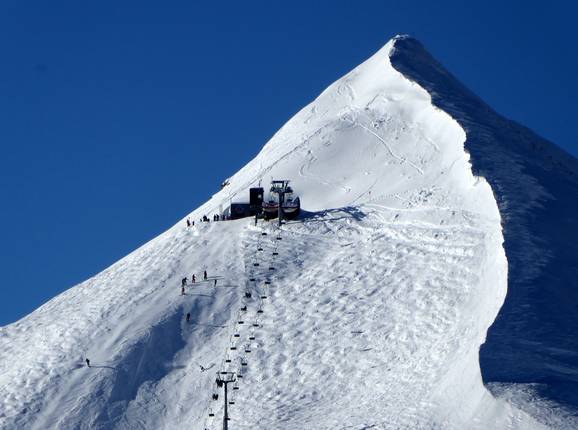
[392,38,578,418]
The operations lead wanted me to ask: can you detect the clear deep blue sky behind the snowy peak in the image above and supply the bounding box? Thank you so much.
[0,0,578,325]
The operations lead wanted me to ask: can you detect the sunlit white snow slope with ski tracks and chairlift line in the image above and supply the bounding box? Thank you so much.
[0,38,571,429]
